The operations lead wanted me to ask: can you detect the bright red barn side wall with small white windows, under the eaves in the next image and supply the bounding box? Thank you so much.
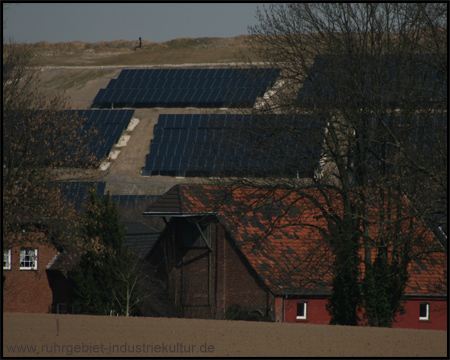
[282,297,447,330]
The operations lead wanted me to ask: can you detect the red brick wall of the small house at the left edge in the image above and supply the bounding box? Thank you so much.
[3,243,58,313]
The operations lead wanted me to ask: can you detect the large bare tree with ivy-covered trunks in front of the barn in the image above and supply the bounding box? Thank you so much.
[212,3,447,326]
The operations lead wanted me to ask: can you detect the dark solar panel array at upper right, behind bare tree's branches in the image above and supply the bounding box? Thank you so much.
[298,55,447,105]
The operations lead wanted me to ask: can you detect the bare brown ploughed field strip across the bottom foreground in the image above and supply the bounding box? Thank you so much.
[3,313,447,358]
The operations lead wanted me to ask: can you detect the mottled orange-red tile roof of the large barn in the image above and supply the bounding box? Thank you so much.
[147,185,447,295]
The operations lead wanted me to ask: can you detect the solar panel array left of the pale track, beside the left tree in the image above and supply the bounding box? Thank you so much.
[64,110,134,160]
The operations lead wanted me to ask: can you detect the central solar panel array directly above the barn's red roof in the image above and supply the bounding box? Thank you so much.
[142,114,320,176]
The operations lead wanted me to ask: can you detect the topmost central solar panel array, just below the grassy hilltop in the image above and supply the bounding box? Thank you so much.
[92,68,280,108]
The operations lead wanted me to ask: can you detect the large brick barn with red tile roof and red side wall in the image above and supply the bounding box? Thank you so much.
[144,185,447,330]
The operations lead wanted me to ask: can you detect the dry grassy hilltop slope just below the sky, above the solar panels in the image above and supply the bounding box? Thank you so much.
[28,35,257,66]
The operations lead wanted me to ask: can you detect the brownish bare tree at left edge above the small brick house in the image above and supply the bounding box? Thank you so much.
[2,38,97,247]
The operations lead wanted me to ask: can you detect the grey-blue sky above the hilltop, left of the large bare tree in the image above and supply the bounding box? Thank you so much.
[3,3,262,43]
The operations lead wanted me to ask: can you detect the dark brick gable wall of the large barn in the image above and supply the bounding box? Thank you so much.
[149,219,275,319]
